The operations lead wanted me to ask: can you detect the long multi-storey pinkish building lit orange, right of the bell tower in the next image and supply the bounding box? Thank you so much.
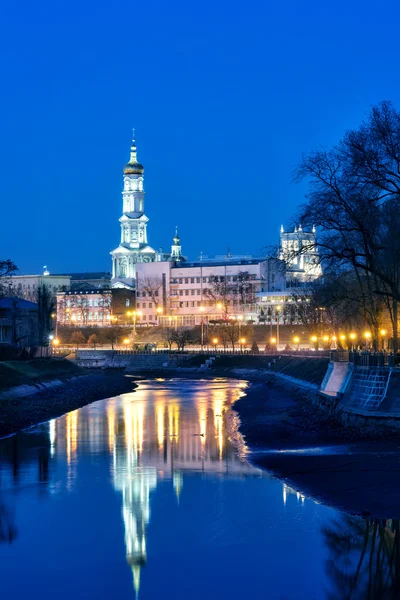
[136,246,285,326]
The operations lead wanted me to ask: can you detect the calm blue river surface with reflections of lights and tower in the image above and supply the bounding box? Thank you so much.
[0,379,400,600]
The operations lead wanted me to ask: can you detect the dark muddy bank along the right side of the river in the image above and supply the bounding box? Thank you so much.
[234,384,400,518]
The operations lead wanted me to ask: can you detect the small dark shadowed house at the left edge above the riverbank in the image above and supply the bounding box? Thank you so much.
[0,296,39,347]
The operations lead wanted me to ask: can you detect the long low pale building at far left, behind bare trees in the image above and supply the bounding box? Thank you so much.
[5,267,71,302]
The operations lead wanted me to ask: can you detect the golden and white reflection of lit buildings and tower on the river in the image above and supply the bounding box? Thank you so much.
[0,380,272,595]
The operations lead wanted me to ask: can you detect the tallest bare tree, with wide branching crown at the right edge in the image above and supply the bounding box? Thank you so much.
[296,102,400,350]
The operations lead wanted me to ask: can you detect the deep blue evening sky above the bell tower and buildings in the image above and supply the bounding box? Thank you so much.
[0,0,400,273]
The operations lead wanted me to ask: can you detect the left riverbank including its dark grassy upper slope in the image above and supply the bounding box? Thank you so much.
[0,361,136,437]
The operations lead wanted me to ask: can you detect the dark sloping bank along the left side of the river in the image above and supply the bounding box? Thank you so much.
[0,369,136,437]
